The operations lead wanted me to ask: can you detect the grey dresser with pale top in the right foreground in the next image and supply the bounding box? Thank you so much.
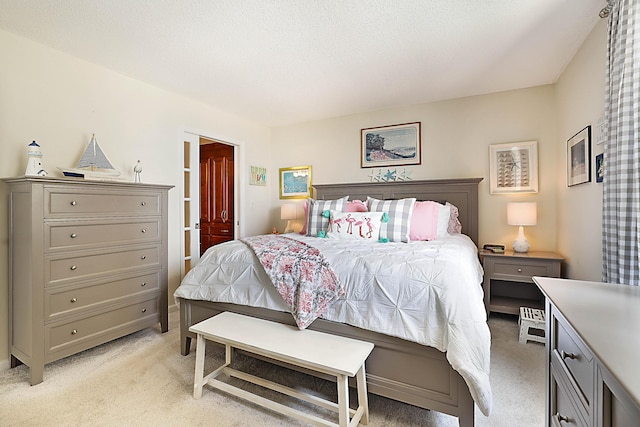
[533,277,640,427]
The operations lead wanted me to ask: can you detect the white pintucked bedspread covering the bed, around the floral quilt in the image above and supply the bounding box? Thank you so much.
[174,234,492,415]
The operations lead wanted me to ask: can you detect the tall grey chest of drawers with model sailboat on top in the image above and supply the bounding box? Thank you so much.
[4,177,171,385]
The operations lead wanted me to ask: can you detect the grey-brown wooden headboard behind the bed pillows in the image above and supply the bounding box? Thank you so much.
[313,178,483,246]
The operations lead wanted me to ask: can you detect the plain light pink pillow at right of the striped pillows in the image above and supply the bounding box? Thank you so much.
[409,201,451,240]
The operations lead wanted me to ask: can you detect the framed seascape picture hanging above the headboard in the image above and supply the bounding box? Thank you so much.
[360,122,422,168]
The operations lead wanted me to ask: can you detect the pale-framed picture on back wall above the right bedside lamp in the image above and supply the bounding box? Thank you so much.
[489,141,538,194]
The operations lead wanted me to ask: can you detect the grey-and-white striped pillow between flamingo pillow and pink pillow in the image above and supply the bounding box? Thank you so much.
[367,197,416,243]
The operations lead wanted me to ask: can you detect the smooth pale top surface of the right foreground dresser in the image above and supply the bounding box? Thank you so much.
[533,277,640,404]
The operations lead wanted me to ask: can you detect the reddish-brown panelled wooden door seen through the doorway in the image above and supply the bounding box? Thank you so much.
[200,140,234,255]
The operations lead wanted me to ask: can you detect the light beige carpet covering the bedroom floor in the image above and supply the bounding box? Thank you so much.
[0,312,545,427]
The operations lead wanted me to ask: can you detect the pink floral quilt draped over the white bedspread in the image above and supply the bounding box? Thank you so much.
[242,234,344,329]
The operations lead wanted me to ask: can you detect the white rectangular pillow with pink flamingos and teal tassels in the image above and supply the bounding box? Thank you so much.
[327,210,384,242]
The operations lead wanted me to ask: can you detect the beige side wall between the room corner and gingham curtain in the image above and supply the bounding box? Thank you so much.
[556,19,607,281]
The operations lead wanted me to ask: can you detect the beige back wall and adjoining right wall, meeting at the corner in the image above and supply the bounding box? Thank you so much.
[271,20,607,281]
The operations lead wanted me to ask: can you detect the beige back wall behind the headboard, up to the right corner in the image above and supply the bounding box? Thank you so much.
[272,86,558,254]
